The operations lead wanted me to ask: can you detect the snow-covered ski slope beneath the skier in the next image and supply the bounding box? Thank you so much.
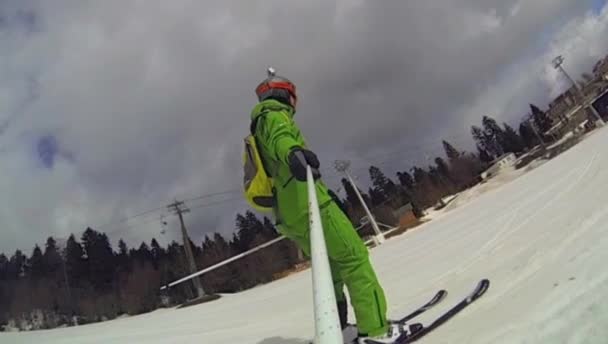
[0,129,608,344]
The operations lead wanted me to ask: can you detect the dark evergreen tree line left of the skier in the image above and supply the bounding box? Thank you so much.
[0,216,299,329]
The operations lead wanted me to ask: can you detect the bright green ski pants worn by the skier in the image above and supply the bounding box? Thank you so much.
[280,201,388,336]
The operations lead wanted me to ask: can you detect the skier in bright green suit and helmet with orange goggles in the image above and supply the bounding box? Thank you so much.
[251,68,401,344]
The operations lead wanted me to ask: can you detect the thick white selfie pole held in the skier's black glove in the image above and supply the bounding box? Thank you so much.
[306,166,344,344]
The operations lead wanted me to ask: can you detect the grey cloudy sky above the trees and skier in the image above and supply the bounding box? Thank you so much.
[0,0,608,253]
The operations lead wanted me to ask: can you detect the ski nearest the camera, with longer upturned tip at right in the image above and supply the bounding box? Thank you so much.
[396,279,490,344]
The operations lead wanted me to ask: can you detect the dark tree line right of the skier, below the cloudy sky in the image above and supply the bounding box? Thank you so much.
[334,104,554,235]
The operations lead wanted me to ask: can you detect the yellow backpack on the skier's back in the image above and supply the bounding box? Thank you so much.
[243,117,275,212]
